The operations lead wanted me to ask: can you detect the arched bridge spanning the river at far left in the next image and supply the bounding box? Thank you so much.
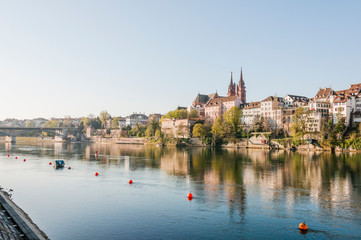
[0,127,78,142]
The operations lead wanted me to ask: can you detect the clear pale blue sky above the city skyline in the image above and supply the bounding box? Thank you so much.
[0,0,361,120]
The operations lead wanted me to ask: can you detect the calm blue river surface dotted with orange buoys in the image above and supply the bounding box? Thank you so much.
[0,142,361,239]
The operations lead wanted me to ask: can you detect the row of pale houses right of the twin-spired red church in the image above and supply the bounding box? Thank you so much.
[240,83,361,132]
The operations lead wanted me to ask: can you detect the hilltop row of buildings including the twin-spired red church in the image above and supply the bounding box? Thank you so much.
[183,71,361,132]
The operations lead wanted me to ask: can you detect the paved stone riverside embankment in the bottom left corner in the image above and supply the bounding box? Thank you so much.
[0,191,48,240]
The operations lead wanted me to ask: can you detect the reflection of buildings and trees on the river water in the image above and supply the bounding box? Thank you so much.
[1,142,361,238]
